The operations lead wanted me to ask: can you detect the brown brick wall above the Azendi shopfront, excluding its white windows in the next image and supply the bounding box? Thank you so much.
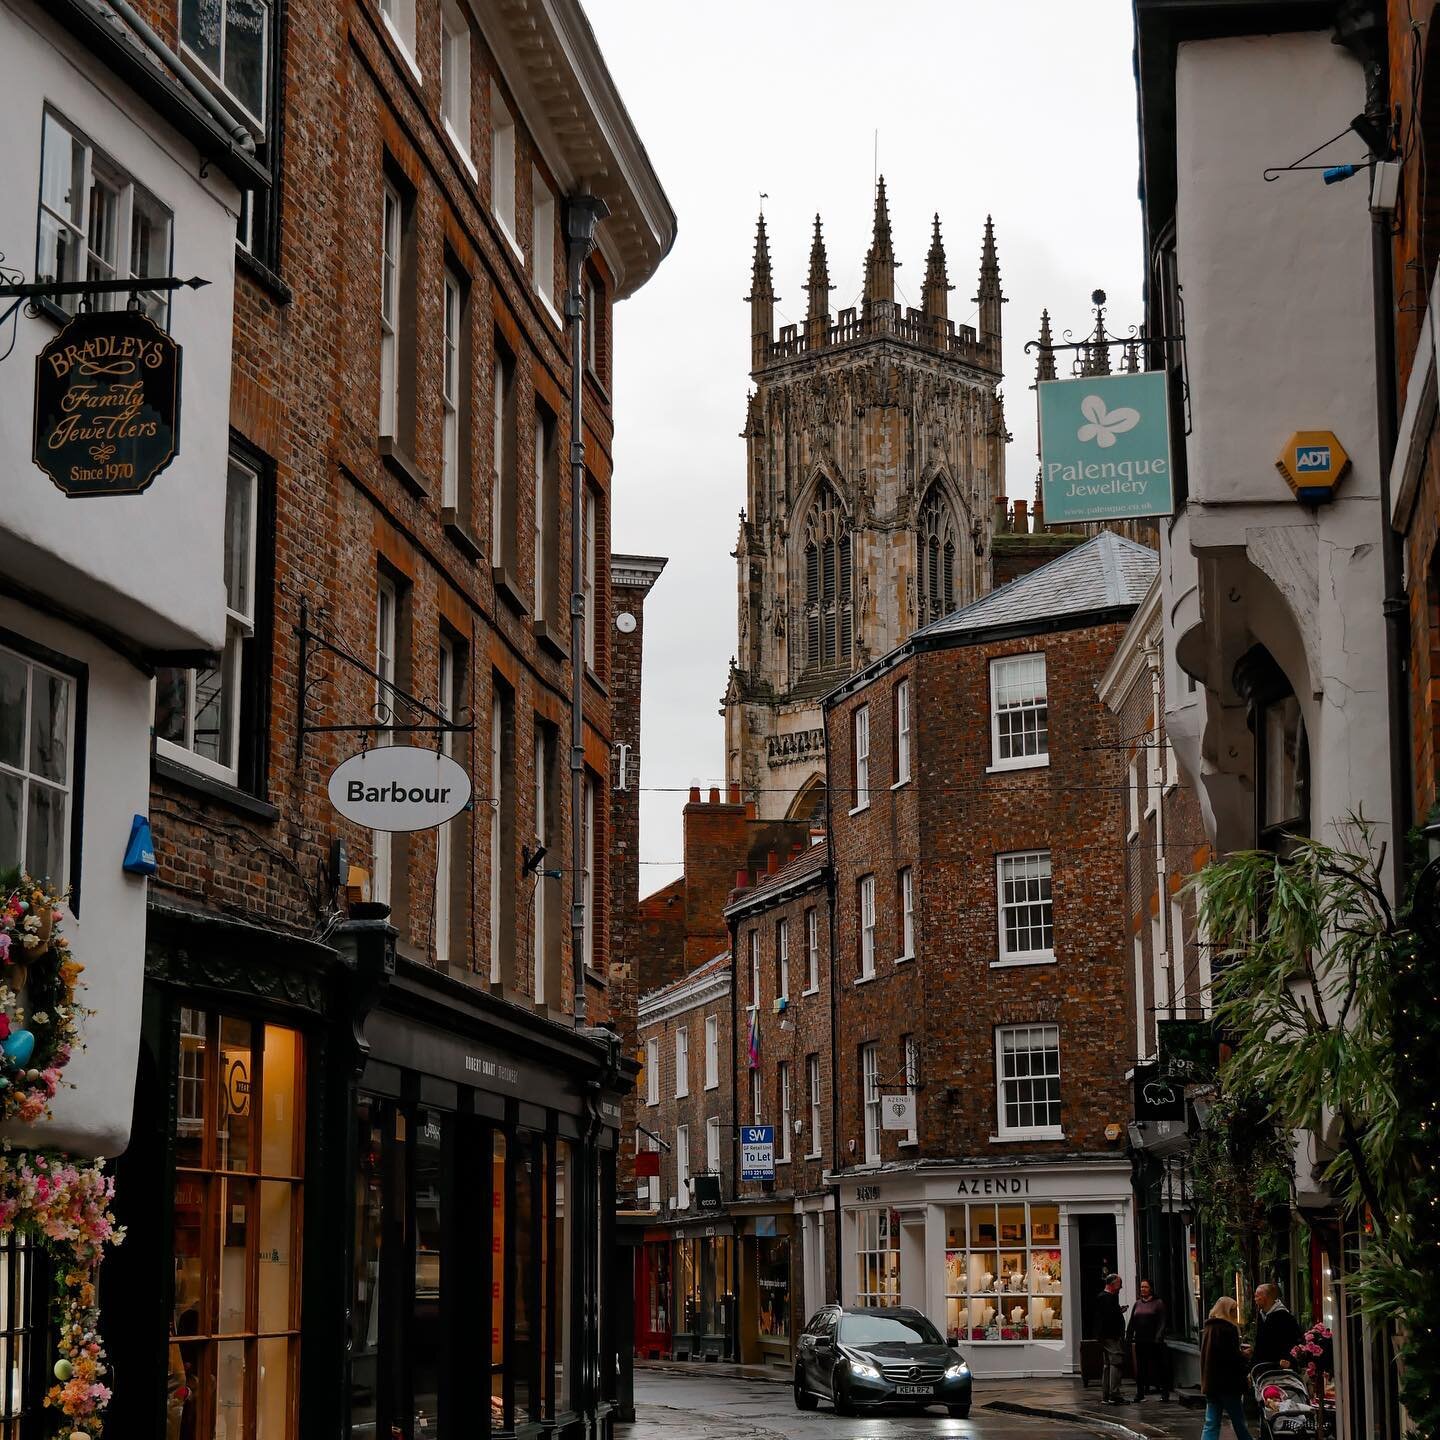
[827,624,1132,1165]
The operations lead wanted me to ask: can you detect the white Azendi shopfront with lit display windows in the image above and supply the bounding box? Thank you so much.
[841,1159,1135,1375]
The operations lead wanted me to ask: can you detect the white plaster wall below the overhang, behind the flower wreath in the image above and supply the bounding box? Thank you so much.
[0,596,151,1155]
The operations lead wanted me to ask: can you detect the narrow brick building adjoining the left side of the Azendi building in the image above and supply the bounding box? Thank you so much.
[726,841,835,1367]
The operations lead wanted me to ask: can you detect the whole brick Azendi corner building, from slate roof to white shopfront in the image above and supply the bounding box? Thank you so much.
[825,533,1155,1374]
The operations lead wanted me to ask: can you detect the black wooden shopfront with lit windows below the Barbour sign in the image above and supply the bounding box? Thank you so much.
[102,906,632,1440]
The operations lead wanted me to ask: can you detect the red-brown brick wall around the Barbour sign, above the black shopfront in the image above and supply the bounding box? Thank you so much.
[153,0,624,1015]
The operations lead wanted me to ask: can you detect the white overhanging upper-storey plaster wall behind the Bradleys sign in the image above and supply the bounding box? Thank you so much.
[0,4,238,649]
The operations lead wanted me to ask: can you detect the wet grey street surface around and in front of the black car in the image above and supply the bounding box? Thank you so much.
[616,1369,1202,1440]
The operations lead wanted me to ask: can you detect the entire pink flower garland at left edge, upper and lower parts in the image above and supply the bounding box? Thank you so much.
[0,874,124,1440]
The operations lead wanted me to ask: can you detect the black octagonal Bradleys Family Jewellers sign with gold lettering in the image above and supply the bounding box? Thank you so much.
[35,310,180,500]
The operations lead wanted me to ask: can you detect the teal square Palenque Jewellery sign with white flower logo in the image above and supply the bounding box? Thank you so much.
[1040,370,1175,526]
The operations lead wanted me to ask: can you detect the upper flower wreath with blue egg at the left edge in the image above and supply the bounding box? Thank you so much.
[0,876,85,1122]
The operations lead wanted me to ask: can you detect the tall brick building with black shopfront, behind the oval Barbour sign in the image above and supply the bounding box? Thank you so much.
[66,0,674,1437]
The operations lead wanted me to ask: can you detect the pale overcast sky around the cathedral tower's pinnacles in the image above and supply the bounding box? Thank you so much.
[583,0,1143,894]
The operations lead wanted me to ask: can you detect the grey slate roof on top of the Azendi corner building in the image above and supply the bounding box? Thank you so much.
[912,530,1159,639]
